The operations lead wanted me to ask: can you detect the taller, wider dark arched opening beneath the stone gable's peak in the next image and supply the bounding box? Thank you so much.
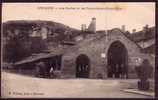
[107,41,128,78]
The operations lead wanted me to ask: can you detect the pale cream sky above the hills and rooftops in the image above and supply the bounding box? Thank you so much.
[2,2,155,32]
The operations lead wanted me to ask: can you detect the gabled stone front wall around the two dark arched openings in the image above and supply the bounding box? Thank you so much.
[61,29,155,78]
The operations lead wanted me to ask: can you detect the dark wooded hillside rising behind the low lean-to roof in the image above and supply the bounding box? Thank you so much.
[2,20,81,62]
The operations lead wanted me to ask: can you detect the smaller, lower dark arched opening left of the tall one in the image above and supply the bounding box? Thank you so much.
[76,54,90,78]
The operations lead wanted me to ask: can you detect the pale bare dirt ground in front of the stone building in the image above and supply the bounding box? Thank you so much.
[1,72,152,98]
